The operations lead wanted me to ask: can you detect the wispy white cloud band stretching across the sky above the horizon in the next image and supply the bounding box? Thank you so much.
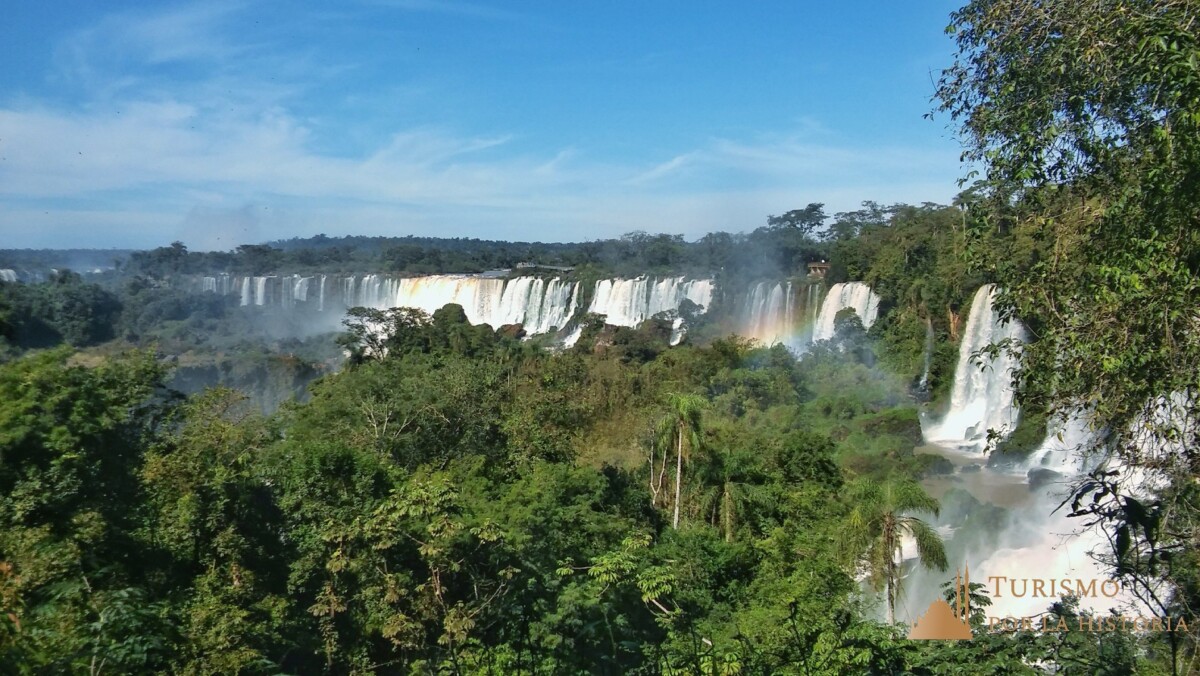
[0,0,955,249]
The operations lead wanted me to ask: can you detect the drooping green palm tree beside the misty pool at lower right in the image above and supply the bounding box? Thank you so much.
[844,477,946,624]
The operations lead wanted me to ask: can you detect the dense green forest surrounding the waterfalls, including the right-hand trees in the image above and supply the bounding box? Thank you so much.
[0,0,1200,675]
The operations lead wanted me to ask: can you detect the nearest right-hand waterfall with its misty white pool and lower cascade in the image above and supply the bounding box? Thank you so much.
[904,286,1128,620]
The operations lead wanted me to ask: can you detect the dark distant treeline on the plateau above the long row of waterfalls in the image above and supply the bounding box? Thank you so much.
[117,202,958,281]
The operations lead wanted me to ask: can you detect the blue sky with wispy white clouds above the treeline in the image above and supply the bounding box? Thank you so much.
[0,0,962,250]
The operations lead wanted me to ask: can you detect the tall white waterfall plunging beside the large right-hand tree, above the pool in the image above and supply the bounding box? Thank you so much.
[925,285,1025,451]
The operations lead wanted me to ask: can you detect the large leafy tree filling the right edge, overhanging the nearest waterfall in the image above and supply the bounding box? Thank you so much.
[937,0,1200,669]
